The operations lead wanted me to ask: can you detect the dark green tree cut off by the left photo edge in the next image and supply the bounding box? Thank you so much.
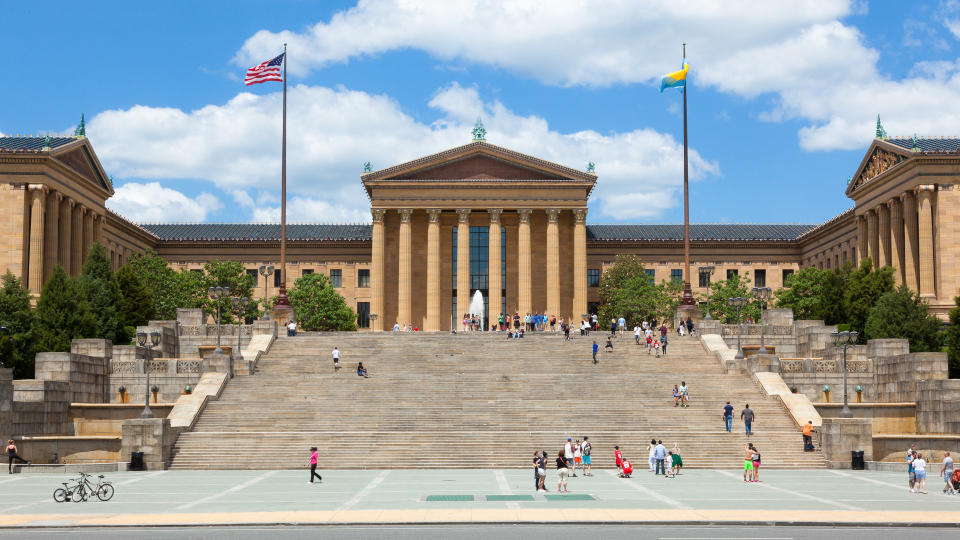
[0,271,34,379]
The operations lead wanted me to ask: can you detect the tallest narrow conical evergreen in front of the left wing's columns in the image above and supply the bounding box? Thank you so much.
[78,242,124,343]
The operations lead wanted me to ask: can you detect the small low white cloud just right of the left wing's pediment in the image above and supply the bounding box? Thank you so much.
[107,182,222,223]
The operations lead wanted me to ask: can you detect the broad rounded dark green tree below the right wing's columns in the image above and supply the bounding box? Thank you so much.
[865,285,941,352]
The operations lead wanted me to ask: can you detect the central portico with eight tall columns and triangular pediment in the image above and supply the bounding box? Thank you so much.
[361,133,597,331]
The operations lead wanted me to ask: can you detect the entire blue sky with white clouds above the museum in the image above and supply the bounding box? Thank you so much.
[0,0,960,223]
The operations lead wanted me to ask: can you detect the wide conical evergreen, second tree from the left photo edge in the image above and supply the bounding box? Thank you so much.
[33,265,97,352]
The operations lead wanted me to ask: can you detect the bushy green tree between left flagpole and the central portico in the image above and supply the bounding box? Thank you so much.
[288,274,357,330]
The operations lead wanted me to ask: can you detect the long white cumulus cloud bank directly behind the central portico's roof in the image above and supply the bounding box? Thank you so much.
[89,83,719,221]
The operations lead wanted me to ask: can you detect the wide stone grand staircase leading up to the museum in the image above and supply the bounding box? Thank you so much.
[171,333,825,469]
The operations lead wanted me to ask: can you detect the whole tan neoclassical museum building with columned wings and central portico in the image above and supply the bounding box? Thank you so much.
[0,122,960,330]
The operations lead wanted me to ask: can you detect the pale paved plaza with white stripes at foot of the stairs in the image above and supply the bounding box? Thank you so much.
[0,470,960,527]
